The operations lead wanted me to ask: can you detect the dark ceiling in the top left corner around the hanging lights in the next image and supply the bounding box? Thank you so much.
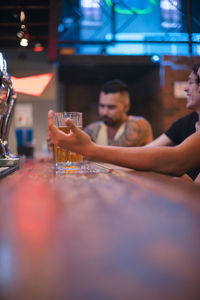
[0,0,61,60]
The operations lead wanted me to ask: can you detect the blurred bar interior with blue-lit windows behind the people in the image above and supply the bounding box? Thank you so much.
[0,0,200,156]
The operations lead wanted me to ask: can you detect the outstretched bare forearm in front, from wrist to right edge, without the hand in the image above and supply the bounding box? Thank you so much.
[90,132,200,176]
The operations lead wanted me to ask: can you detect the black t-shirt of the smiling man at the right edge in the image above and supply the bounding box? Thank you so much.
[165,112,200,180]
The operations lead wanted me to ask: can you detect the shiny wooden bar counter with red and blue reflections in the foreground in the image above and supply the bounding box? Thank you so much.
[0,161,200,300]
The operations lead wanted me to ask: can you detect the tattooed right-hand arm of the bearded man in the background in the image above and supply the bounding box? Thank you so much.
[112,117,153,147]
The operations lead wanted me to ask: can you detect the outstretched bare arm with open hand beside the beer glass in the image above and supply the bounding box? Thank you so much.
[48,111,200,176]
